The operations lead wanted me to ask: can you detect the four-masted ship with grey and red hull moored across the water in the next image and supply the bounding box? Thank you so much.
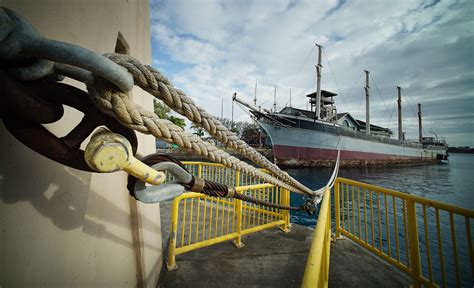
[233,44,449,167]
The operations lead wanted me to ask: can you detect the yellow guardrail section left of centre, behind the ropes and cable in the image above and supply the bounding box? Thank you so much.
[166,162,290,270]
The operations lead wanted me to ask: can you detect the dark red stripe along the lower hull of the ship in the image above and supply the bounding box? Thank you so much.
[273,145,421,160]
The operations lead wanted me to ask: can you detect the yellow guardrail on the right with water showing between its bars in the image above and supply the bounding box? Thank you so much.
[334,178,474,287]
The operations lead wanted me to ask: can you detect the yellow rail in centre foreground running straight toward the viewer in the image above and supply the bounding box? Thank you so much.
[301,188,331,288]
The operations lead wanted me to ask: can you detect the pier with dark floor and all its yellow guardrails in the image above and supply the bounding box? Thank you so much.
[155,162,474,287]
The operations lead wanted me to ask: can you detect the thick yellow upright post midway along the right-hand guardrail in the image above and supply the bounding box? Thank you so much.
[406,200,421,287]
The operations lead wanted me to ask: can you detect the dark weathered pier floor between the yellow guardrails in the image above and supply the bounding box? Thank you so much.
[158,203,411,287]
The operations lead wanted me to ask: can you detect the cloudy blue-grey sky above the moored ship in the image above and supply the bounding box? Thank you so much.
[151,0,474,147]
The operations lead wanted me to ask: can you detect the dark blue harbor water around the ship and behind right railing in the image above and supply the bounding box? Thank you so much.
[286,154,474,287]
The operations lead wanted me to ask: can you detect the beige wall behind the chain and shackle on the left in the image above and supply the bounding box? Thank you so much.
[0,0,162,288]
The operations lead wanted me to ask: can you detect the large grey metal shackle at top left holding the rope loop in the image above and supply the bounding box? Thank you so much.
[0,8,133,92]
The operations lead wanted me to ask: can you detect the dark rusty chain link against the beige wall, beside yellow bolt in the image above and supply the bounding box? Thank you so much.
[0,71,137,172]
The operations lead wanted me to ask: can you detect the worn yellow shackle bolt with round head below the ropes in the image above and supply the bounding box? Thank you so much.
[84,129,166,185]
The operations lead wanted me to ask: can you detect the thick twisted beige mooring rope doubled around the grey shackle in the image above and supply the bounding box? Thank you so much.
[88,54,314,195]
